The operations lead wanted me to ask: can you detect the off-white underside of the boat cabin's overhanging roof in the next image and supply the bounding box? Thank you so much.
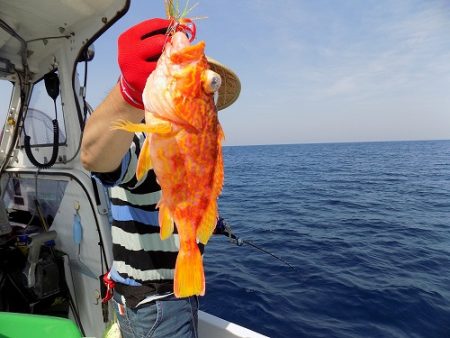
[0,0,129,77]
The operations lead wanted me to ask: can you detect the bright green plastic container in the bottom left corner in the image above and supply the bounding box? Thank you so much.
[0,312,82,338]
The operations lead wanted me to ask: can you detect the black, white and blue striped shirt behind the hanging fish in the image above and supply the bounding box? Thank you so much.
[94,133,179,286]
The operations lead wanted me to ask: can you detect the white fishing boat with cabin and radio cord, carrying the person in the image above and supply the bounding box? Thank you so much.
[0,0,264,338]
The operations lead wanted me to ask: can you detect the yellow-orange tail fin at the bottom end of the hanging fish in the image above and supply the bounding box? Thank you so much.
[173,241,205,298]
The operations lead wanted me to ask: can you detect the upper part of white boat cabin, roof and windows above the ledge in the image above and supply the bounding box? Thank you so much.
[0,0,130,172]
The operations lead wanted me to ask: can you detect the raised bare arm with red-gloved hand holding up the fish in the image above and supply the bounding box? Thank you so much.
[81,18,170,173]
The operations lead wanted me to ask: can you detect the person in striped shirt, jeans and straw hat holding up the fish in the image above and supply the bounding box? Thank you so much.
[81,18,240,338]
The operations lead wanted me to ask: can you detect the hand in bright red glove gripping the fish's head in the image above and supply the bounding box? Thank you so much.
[118,18,170,109]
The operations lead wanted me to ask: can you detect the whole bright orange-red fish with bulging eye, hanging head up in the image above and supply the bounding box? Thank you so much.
[114,32,224,297]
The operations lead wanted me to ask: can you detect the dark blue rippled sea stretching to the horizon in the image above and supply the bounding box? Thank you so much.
[201,141,450,338]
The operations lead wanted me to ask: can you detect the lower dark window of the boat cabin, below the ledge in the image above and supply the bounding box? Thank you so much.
[3,177,68,227]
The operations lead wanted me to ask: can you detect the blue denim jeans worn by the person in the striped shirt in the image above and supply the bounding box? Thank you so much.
[113,292,198,338]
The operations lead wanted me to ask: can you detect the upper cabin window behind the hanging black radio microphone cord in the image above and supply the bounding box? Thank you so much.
[21,74,66,146]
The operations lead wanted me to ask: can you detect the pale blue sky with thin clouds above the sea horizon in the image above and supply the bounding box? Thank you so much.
[3,0,450,145]
